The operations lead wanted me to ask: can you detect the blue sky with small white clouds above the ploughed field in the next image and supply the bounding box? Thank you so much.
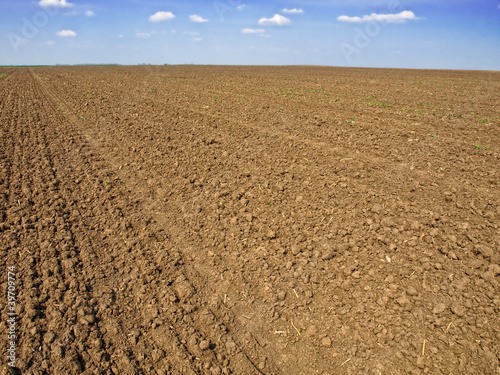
[0,0,500,70]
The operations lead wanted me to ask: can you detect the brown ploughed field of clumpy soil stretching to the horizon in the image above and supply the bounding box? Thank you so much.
[0,66,500,375]
